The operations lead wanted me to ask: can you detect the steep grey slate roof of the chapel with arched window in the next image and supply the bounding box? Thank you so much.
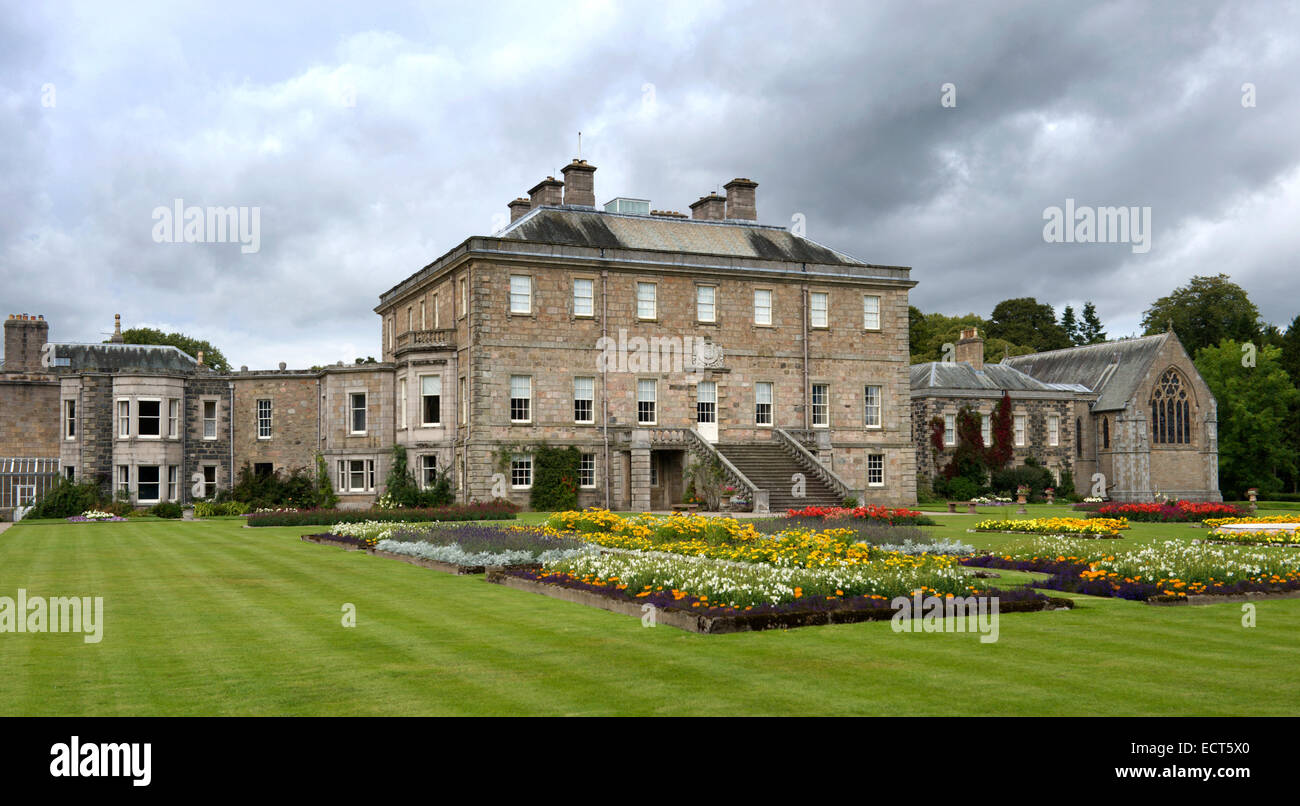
[1002,333,1171,411]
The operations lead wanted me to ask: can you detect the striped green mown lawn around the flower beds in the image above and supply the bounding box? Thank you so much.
[0,508,1300,715]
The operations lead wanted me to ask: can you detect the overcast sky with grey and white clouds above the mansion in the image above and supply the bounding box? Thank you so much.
[0,0,1300,368]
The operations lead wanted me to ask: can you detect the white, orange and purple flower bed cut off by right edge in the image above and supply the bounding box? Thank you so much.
[962,541,1300,601]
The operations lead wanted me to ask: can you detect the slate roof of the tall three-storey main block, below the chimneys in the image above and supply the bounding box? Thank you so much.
[499,205,870,267]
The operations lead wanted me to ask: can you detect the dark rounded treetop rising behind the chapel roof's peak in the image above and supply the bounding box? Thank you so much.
[1141,274,1261,356]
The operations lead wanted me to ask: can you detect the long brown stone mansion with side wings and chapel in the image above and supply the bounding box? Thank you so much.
[0,160,1218,511]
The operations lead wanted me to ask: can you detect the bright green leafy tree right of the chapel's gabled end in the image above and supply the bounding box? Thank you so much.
[1196,338,1300,495]
